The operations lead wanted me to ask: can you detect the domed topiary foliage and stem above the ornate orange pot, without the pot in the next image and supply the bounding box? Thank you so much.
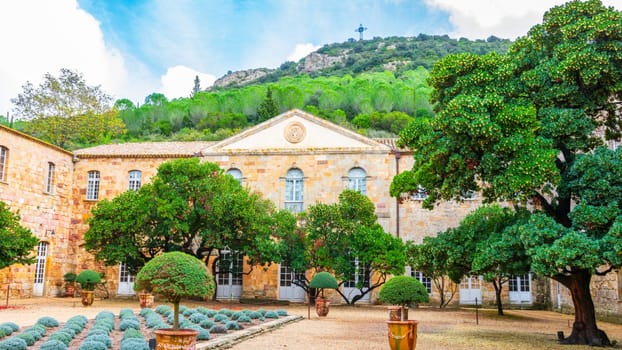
[378,276,430,321]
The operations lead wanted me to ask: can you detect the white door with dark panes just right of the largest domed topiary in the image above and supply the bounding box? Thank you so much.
[216,252,244,299]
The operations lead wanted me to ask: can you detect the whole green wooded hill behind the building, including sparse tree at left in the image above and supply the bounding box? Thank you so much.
[0,34,511,149]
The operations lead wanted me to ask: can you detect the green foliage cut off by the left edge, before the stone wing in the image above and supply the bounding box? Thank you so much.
[0,201,39,269]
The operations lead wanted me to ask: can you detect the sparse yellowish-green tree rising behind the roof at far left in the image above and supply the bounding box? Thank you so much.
[11,69,125,147]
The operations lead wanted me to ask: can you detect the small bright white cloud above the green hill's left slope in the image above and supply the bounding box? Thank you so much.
[160,65,216,99]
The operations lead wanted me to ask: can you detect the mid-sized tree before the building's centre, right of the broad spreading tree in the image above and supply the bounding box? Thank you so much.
[294,190,405,304]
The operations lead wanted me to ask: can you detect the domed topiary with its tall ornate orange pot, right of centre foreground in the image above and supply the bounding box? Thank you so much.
[378,276,430,350]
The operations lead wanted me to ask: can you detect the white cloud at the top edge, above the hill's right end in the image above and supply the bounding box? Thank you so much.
[424,0,622,39]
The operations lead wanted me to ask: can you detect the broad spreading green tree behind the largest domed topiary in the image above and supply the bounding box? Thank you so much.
[84,158,295,282]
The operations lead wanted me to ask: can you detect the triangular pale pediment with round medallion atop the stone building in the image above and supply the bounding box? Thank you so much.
[202,109,390,155]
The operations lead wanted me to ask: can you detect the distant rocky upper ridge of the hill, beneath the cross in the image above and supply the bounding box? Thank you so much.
[210,34,512,90]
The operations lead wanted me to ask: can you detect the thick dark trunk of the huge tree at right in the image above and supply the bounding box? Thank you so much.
[560,270,611,346]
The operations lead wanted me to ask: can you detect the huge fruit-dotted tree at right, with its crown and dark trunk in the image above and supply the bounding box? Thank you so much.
[391,0,622,344]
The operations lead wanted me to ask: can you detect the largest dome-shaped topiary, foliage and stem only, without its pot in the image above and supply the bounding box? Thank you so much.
[134,252,215,330]
